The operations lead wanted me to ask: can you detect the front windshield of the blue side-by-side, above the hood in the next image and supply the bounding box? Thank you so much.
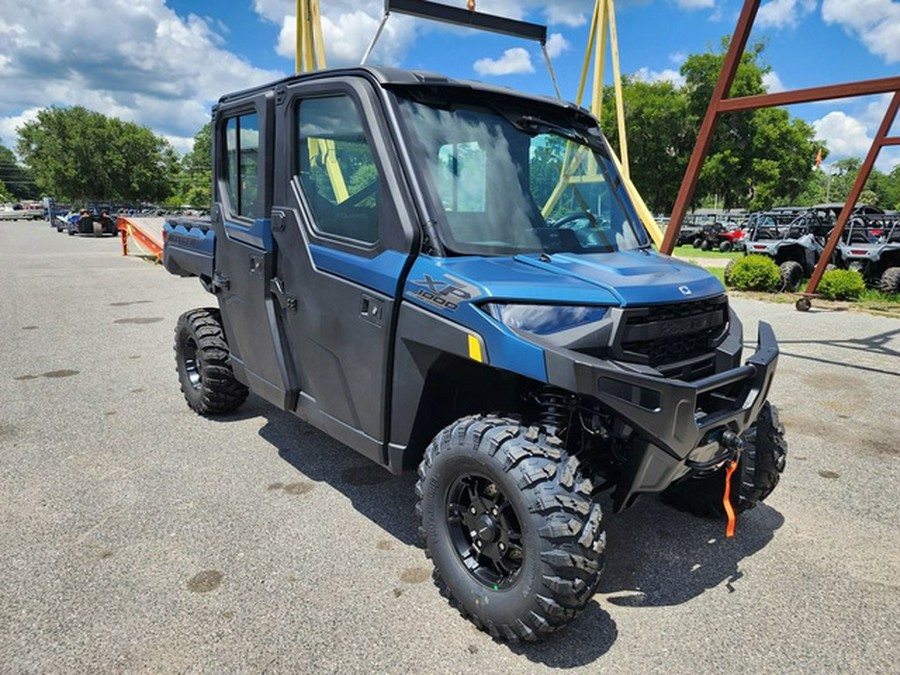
[400,98,648,255]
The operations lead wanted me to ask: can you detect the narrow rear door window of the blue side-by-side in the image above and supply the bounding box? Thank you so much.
[225,113,259,218]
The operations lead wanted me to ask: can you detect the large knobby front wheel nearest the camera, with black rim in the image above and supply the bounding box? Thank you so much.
[416,415,606,641]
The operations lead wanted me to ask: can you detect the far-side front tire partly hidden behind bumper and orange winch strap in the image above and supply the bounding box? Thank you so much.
[662,403,787,517]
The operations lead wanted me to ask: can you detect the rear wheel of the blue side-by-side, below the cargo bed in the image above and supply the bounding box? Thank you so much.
[175,309,249,415]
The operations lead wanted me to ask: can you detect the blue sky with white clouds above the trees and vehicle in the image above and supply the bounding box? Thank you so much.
[0,0,900,170]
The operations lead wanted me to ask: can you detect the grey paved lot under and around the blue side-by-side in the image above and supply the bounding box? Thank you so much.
[0,223,900,673]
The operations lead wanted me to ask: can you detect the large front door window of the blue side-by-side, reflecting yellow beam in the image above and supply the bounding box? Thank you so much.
[296,95,381,244]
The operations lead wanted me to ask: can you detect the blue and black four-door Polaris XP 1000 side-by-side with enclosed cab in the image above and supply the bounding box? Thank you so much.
[165,68,786,640]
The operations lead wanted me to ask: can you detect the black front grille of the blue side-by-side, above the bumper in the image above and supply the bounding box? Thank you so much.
[619,295,728,379]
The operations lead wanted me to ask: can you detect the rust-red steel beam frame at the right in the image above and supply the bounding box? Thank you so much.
[660,0,900,294]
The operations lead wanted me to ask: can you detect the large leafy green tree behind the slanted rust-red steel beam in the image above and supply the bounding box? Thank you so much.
[602,43,827,213]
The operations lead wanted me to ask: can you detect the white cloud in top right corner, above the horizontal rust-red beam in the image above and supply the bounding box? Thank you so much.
[822,0,900,63]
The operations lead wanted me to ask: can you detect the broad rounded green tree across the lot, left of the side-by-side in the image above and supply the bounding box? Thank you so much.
[17,106,178,202]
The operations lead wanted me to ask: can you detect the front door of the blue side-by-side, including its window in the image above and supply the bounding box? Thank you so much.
[271,77,416,463]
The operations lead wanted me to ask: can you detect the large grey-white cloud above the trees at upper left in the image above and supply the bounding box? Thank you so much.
[0,0,281,151]
